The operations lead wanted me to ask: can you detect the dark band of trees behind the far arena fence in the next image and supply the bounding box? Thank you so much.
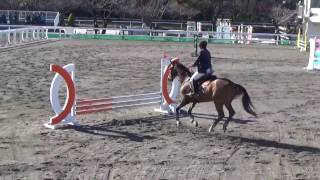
[0,0,299,24]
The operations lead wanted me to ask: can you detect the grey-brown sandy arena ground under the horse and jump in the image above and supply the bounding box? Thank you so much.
[0,40,320,180]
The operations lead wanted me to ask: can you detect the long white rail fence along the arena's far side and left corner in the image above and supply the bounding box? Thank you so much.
[0,26,297,48]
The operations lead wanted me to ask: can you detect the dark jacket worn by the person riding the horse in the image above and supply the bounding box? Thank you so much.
[192,49,212,73]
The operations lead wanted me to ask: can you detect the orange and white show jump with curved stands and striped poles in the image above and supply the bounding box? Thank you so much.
[45,58,180,129]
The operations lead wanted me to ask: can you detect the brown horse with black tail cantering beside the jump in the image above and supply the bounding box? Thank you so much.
[170,62,257,132]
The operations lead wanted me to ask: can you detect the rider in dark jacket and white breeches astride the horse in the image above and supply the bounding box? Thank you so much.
[189,41,213,95]
